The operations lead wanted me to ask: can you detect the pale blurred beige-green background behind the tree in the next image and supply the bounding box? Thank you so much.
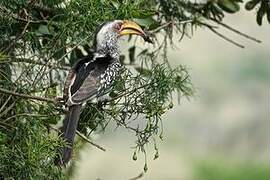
[73,12,270,180]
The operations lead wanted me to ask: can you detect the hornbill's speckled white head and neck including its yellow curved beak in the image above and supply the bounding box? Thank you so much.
[94,20,152,57]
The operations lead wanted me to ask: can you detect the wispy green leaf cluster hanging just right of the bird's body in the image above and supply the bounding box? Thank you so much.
[79,64,193,148]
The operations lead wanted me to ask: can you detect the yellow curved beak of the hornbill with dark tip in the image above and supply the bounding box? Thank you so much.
[119,20,153,43]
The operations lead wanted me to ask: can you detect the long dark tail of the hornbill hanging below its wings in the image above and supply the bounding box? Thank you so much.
[58,105,81,165]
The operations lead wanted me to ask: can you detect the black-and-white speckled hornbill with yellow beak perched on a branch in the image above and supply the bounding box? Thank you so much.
[58,20,151,165]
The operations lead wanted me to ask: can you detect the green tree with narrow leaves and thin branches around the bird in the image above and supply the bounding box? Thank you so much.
[0,0,270,179]
